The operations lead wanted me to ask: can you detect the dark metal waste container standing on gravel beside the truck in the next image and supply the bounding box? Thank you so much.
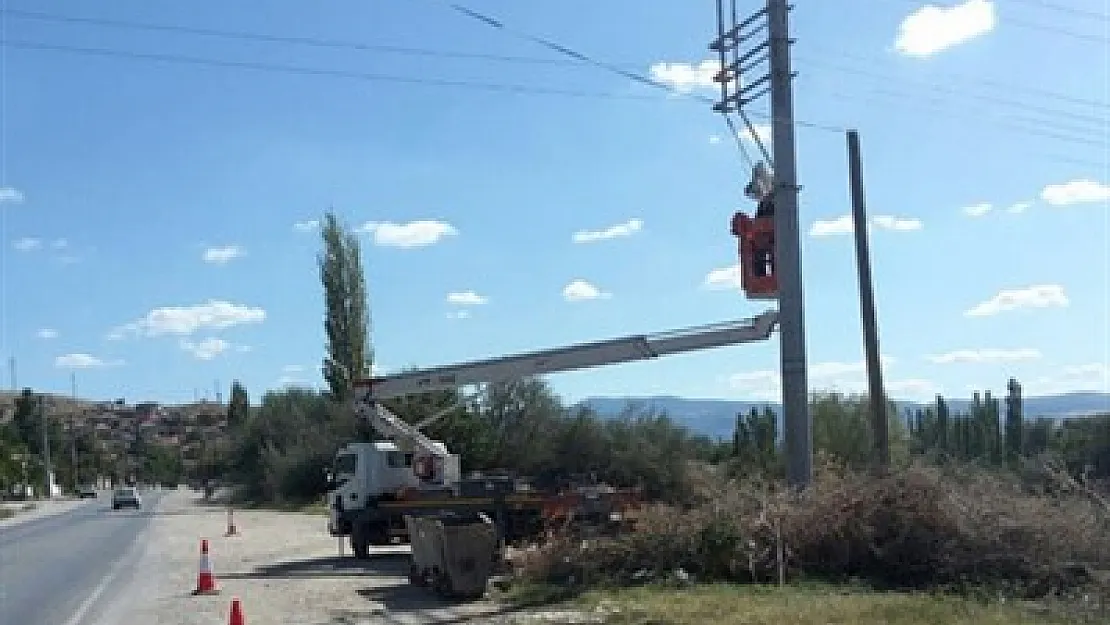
[405,513,498,598]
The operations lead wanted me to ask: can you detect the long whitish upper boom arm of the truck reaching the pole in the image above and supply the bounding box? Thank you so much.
[355,311,778,401]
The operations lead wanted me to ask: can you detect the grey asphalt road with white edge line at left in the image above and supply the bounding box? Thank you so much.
[0,491,160,625]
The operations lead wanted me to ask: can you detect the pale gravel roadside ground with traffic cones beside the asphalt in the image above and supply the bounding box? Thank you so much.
[102,490,599,625]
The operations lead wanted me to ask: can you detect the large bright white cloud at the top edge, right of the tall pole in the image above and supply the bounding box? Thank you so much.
[895,0,998,59]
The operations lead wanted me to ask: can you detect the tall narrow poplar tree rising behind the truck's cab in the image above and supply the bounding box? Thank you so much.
[317,211,373,401]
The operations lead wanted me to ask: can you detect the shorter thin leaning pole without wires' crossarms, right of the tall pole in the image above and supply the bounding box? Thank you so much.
[848,130,890,472]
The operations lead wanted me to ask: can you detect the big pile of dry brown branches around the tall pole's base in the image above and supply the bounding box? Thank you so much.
[519,460,1110,596]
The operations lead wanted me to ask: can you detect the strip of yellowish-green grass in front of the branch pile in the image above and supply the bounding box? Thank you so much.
[506,584,1074,625]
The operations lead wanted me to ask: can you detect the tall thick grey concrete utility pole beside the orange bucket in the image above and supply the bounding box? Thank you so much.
[767,0,814,487]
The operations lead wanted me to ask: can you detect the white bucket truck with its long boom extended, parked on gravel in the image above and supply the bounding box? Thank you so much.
[327,311,778,558]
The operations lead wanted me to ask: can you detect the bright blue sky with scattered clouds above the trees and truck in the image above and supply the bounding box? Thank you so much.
[0,0,1110,402]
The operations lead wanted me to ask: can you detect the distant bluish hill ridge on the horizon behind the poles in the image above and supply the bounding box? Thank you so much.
[579,393,1110,438]
